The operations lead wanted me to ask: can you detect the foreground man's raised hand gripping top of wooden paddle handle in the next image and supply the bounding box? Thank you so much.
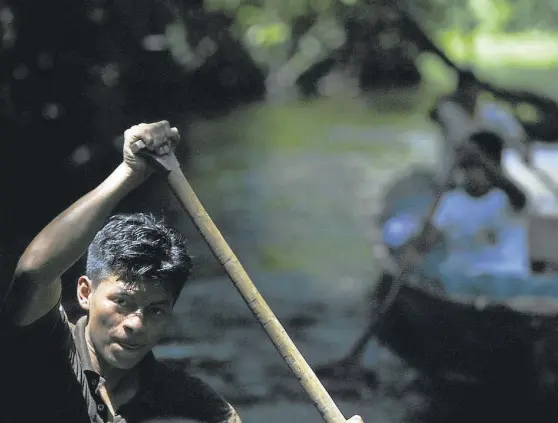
[124,120,180,176]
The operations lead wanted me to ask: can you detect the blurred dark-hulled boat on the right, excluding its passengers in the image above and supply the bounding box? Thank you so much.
[372,148,558,394]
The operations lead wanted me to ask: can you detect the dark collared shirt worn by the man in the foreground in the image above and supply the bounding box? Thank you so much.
[0,307,240,423]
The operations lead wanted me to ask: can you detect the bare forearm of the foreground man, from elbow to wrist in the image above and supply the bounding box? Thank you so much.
[15,165,144,283]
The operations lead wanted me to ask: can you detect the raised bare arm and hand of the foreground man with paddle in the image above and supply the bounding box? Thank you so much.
[6,121,179,326]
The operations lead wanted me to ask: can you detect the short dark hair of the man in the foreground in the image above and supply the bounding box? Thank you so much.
[86,213,192,300]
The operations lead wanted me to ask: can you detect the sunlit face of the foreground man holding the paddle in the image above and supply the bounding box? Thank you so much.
[78,277,173,369]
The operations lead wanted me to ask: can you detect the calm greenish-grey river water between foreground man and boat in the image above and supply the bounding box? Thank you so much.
[148,93,446,423]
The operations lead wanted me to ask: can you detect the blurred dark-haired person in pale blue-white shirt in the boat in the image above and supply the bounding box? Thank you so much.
[433,140,529,280]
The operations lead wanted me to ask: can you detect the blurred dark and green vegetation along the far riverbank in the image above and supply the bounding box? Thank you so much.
[0,0,558,290]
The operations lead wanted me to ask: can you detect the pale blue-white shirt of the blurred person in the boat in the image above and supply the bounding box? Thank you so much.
[433,188,529,277]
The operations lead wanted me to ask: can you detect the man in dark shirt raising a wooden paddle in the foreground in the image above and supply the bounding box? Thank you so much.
[0,121,361,423]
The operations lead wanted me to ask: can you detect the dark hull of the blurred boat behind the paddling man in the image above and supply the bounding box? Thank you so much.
[376,278,558,390]
